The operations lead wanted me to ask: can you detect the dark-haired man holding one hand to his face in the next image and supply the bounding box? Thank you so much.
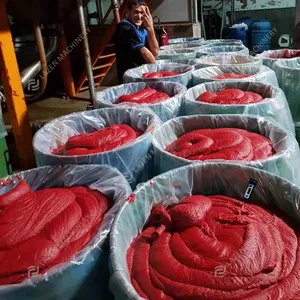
[115,0,159,83]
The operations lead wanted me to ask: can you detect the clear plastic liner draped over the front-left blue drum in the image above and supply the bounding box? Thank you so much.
[0,165,131,300]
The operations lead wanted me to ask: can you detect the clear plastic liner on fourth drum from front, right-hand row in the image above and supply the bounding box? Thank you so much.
[192,66,278,87]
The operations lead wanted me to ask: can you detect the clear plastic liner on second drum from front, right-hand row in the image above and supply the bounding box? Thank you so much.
[152,114,300,184]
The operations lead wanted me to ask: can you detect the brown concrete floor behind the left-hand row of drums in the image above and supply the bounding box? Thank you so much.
[3,86,107,127]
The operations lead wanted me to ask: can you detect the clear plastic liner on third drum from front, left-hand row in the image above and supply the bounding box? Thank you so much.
[96,82,187,122]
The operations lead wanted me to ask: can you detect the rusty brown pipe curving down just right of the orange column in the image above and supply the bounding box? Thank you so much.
[25,21,48,101]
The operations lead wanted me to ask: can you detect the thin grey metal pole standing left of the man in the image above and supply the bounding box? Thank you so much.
[77,0,96,105]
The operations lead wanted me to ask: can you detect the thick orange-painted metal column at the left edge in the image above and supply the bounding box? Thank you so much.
[0,0,35,169]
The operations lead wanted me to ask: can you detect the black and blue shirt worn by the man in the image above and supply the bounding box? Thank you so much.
[114,20,149,82]
